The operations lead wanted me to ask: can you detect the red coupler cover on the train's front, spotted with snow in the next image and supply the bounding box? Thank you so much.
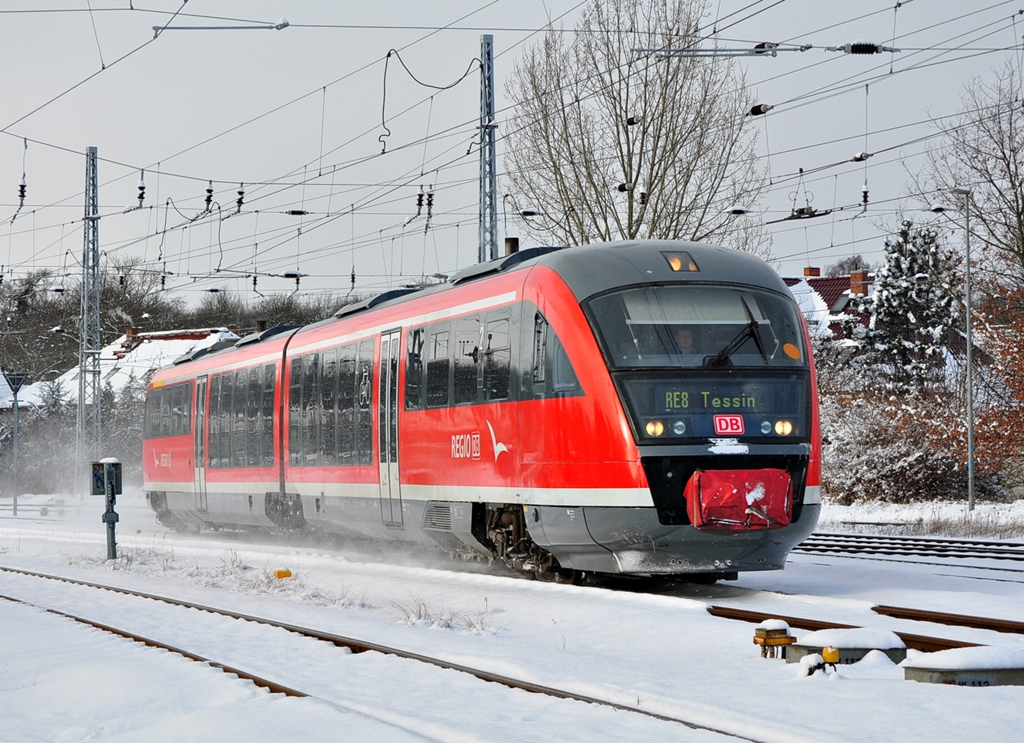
[683,469,793,530]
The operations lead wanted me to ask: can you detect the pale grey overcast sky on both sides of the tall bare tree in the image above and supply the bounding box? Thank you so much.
[0,0,1024,300]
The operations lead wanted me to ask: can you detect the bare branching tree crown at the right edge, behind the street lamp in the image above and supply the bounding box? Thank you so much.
[915,63,1024,287]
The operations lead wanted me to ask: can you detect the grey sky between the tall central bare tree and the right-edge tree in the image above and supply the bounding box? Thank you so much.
[722,0,1024,273]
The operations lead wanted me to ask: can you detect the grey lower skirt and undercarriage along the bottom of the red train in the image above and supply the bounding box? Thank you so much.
[147,491,817,582]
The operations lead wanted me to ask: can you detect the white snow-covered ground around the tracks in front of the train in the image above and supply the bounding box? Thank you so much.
[0,493,1024,743]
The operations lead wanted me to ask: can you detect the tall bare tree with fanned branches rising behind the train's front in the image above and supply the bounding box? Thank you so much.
[506,0,770,257]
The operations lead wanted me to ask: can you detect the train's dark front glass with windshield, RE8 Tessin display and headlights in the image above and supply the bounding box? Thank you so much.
[586,285,810,443]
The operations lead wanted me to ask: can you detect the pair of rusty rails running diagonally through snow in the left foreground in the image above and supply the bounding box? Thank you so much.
[0,566,762,743]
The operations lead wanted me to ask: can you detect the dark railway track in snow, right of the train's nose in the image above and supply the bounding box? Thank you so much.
[793,533,1024,563]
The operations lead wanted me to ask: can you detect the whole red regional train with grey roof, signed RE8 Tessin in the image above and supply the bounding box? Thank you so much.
[143,242,820,579]
